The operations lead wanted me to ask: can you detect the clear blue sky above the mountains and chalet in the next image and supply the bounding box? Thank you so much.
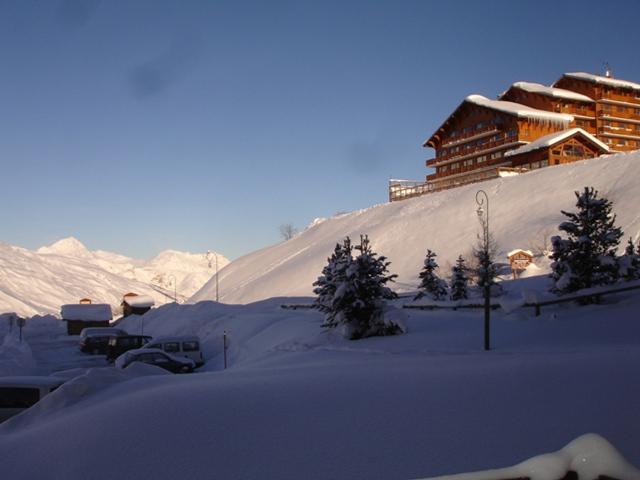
[0,0,640,258]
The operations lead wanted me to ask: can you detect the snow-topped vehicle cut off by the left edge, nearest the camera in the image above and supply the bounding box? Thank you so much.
[0,376,66,422]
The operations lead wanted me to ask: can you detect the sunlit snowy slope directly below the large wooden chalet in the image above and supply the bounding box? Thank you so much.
[192,152,640,303]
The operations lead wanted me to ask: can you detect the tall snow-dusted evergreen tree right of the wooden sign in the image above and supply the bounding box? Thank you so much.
[550,187,622,293]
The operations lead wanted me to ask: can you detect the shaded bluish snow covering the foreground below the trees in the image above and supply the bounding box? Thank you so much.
[0,282,640,480]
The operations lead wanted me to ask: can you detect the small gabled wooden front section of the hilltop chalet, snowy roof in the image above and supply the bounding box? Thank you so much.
[505,128,609,170]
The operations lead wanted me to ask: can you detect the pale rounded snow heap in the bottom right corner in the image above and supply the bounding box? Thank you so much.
[423,433,640,480]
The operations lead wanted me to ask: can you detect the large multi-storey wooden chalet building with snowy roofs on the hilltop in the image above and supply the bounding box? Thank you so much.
[389,72,640,201]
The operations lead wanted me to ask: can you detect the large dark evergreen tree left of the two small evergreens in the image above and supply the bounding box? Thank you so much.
[316,236,402,340]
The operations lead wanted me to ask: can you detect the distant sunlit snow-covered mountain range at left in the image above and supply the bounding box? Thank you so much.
[0,237,229,316]
